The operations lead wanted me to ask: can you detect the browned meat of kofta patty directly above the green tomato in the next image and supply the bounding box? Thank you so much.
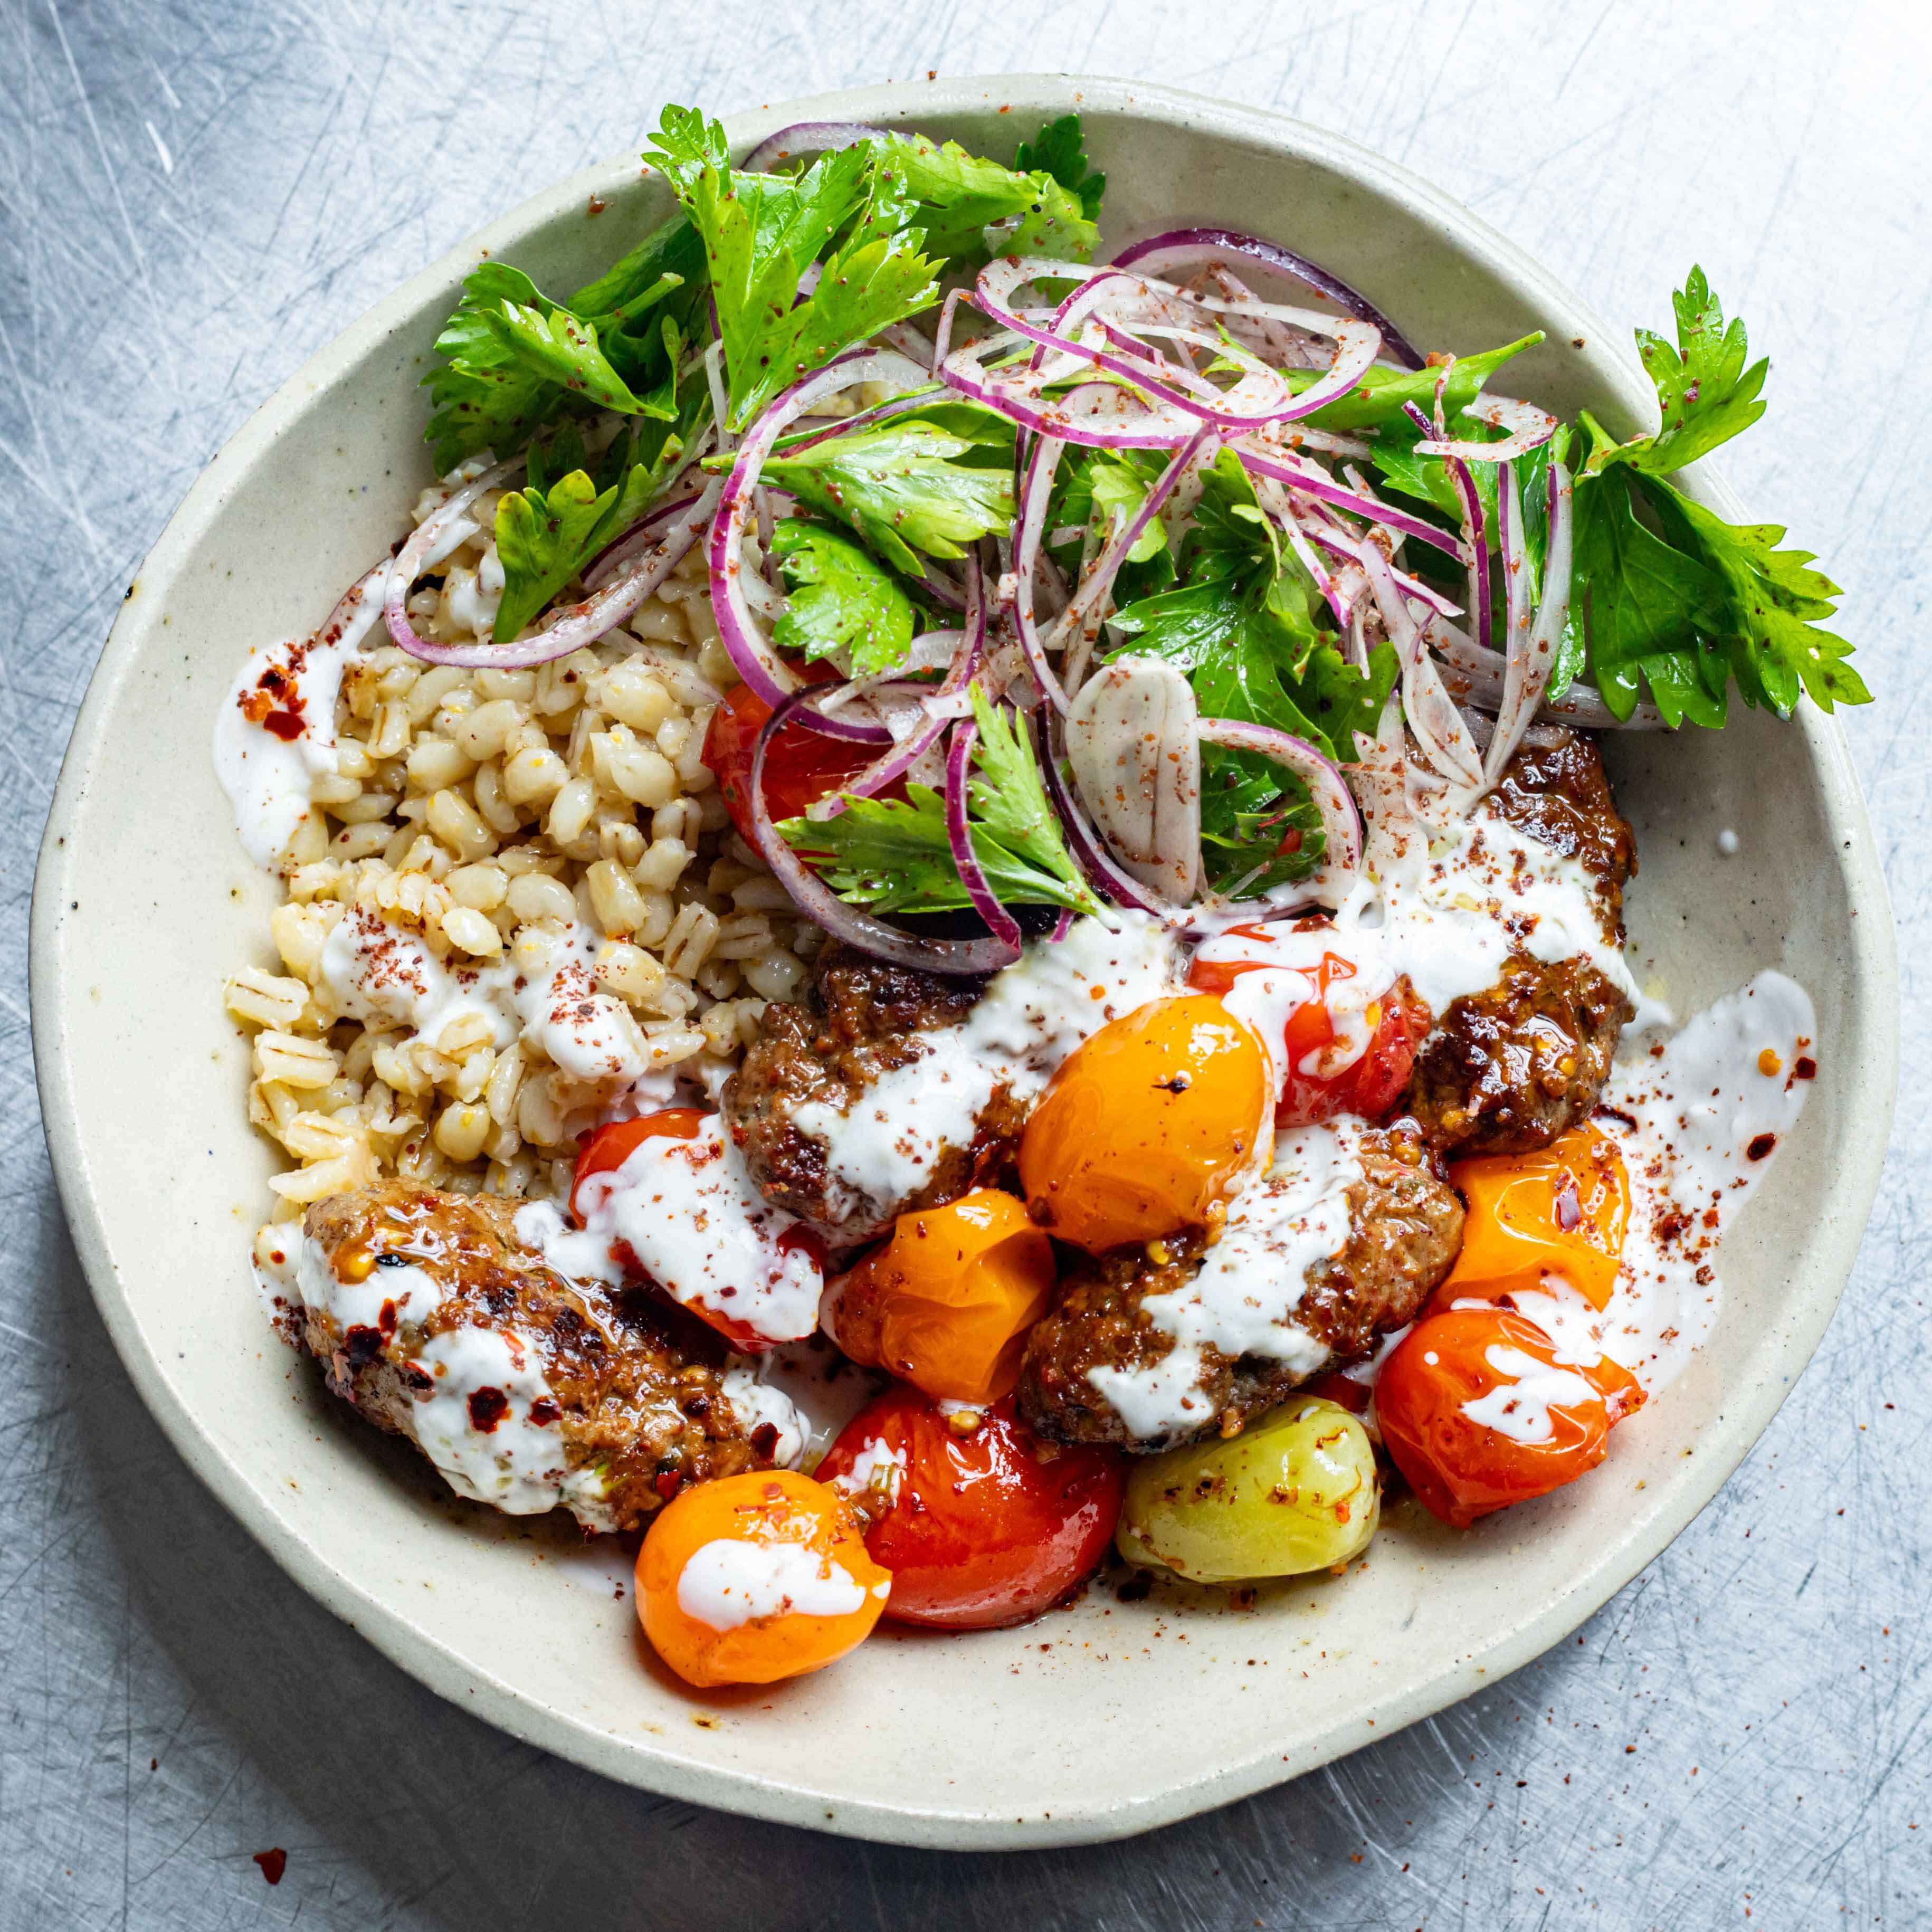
[1020,1128,1462,1449]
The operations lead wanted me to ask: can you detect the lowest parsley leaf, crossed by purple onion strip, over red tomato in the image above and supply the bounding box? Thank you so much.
[778,686,1101,912]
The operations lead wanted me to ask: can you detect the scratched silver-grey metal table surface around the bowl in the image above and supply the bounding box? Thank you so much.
[0,0,1932,1932]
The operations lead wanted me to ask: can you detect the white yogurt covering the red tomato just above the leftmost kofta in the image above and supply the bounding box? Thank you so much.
[516,1115,825,1345]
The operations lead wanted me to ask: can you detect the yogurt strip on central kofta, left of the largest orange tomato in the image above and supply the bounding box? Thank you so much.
[792,912,1184,1223]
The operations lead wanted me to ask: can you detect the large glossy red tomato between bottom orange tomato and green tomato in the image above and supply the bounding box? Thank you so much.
[815,1387,1126,1631]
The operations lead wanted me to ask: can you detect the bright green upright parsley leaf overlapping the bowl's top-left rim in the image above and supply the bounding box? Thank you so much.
[645,106,939,429]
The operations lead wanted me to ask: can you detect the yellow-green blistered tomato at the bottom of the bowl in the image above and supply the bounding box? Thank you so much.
[1115,1395,1382,1582]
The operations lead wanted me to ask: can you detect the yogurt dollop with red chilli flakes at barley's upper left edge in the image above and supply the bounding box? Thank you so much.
[214,562,388,868]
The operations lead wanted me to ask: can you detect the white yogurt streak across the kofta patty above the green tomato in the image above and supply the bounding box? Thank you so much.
[1088,1119,1362,1441]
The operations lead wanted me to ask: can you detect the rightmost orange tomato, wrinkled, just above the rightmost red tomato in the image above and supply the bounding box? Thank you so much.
[1435,1126,1631,1308]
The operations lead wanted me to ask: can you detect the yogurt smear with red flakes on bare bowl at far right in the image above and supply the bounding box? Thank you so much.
[1459,972,1818,1401]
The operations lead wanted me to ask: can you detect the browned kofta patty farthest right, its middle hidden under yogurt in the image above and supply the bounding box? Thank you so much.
[1405,730,1636,1154]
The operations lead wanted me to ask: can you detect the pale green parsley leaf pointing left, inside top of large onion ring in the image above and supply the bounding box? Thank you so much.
[765,412,1014,578]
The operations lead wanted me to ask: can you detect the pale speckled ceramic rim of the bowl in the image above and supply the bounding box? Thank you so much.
[29,73,1899,1851]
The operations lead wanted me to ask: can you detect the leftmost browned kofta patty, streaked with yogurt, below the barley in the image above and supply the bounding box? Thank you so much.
[303,1181,778,1530]
